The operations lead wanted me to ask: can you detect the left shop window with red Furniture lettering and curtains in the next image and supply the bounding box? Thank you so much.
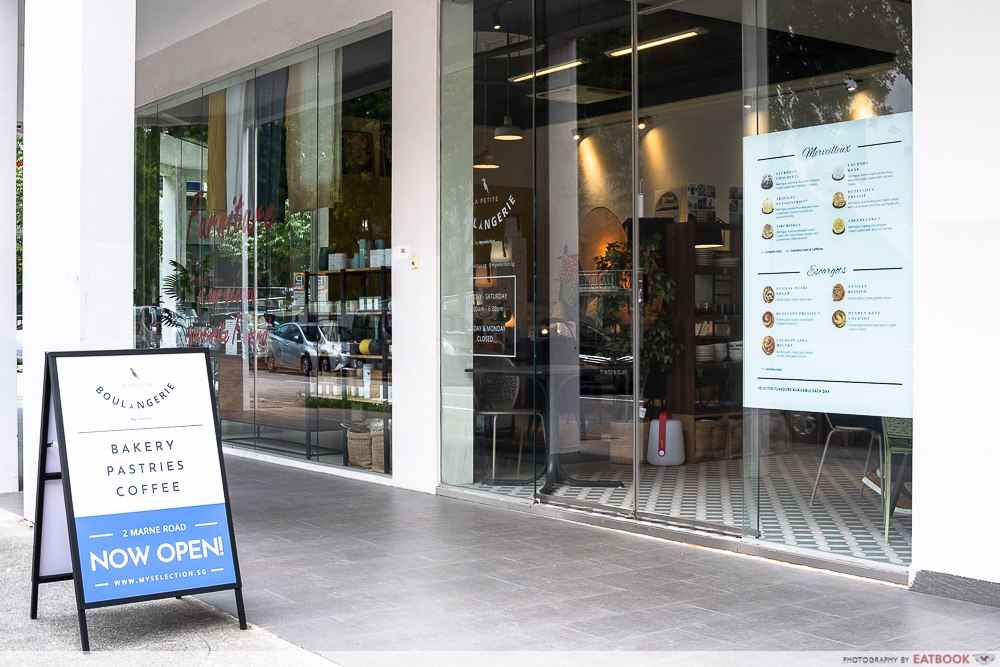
[135,22,393,473]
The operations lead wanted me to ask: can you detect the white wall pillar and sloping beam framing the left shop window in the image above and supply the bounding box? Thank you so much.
[136,0,440,492]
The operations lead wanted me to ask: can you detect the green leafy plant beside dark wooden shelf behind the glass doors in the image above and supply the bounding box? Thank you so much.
[594,234,681,400]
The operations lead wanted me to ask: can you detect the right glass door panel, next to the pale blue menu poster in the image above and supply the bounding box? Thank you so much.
[621,0,744,534]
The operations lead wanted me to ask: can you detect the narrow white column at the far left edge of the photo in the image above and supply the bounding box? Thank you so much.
[0,0,18,493]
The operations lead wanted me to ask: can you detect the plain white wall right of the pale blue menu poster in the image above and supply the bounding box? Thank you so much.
[911,0,1000,582]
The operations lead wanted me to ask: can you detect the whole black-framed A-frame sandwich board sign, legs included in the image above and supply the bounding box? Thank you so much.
[30,348,247,651]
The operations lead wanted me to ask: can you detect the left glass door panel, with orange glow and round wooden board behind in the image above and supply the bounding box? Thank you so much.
[532,0,641,514]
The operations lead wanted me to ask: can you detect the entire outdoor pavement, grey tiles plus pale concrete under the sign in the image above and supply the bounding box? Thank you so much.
[0,455,1000,666]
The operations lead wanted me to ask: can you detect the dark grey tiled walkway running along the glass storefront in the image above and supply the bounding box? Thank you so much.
[193,457,1000,651]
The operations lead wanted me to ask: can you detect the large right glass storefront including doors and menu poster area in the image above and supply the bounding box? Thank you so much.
[441,0,912,565]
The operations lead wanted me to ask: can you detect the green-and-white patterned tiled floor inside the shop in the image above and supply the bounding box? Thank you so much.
[473,446,912,566]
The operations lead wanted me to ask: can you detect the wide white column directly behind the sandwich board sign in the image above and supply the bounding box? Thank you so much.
[21,0,135,517]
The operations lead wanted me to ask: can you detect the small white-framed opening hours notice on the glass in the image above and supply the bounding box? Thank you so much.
[472,276,517,357]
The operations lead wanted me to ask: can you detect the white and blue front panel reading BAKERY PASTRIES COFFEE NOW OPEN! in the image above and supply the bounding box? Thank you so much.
[53,351,237,603]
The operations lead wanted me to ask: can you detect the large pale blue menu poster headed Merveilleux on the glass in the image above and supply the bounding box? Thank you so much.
[743,113,913,417]
